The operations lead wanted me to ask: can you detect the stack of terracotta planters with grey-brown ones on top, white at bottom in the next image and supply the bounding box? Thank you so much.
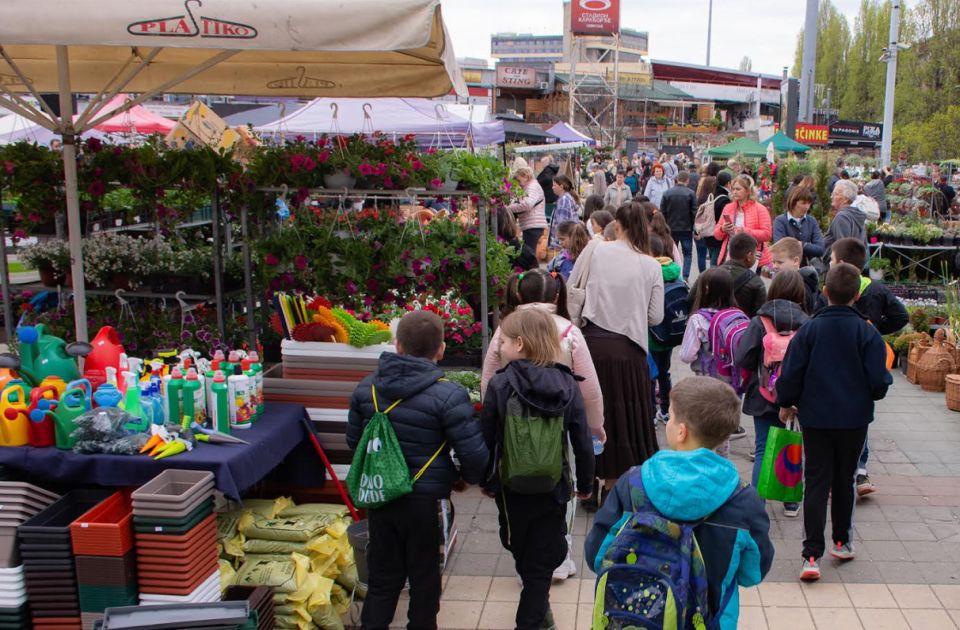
[133,469,220,604]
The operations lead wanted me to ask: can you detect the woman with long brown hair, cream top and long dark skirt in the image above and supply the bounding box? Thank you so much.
[568,202,663,500]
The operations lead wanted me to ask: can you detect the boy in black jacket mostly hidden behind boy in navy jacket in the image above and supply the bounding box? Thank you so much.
[822,237,910,497]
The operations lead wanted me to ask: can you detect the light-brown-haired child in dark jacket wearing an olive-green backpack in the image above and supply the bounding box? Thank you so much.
[480,309,595,630]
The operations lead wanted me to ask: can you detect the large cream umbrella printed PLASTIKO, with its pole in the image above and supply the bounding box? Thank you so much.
[0,0,467,341]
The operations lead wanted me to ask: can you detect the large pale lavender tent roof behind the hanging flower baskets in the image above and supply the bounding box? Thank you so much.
[254,98,504,148]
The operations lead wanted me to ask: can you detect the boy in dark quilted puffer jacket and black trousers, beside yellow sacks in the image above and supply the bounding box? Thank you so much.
[347,311,488,630]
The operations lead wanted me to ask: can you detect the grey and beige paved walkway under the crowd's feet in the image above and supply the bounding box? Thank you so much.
[354,361,960,630]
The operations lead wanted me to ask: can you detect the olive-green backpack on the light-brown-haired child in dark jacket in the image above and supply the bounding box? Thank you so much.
[499,391,564,494]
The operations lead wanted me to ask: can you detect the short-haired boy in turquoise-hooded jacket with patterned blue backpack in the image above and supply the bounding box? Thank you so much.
[585,378,774,630]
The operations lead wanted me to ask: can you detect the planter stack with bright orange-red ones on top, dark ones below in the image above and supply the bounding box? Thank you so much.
[70,492,138,630]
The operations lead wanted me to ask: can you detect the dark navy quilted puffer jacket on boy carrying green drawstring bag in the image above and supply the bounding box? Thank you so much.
[347,353,489,498]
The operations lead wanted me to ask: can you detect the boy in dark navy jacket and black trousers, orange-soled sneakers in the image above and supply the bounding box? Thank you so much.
[777,263,893,580]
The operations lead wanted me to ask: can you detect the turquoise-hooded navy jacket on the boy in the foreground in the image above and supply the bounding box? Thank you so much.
[584,448,773,630]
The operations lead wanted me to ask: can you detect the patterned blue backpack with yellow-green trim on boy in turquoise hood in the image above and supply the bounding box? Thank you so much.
[592,466,745,630]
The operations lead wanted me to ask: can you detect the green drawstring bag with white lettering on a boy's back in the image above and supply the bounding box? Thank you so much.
[347,384,447,508]
